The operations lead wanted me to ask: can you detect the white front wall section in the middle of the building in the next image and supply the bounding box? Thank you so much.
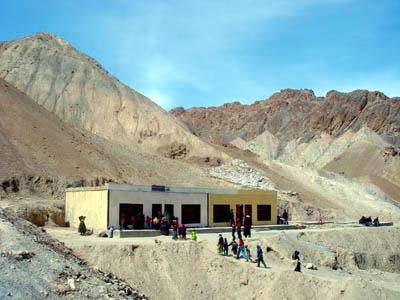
[109,190,208,227]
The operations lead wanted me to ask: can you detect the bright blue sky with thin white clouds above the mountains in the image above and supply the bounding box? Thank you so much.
[0,0,400,109]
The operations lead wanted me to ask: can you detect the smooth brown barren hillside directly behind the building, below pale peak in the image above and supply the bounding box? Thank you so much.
[0,79,230,195]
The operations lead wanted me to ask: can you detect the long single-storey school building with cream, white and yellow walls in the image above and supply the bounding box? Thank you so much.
[65,183,277,230]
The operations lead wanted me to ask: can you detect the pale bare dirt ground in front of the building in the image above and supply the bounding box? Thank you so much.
[47,225,400,299]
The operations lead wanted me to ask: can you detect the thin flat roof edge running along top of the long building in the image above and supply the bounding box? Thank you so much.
[65,183,276,194]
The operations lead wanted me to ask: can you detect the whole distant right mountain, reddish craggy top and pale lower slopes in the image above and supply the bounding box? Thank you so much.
[171,89,400,204]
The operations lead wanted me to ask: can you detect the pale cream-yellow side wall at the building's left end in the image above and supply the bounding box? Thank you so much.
[65,190,108,230]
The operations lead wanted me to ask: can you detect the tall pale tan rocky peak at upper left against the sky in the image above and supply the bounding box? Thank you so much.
[0,33,226,159]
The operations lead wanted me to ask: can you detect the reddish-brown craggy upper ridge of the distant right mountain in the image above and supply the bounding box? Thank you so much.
[171,89,400,143]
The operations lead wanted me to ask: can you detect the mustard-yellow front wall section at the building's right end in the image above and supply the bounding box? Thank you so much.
[208,190,278,226]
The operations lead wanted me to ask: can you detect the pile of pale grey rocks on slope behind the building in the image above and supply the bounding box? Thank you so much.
[209,159,276,190]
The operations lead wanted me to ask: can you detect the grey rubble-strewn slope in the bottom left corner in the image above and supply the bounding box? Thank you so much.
[0,208,146,299]
